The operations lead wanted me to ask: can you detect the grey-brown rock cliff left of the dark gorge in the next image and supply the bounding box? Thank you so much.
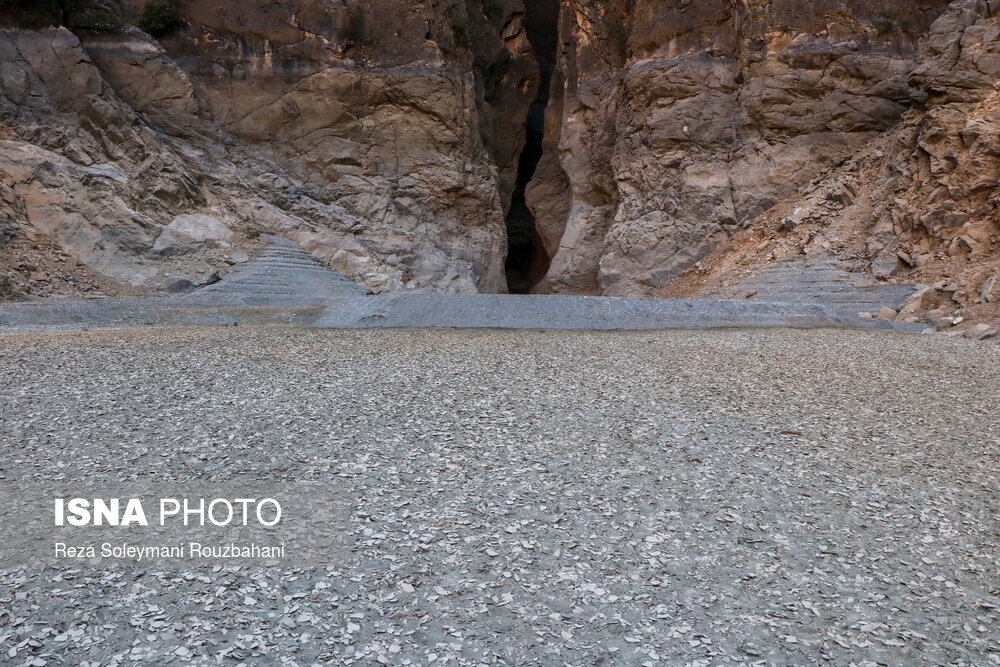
[0,0,538,292]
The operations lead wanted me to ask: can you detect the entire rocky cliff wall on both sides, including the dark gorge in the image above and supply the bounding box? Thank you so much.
[0,0,1000,320]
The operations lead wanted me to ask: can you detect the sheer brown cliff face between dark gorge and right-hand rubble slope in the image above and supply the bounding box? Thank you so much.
[529,0,964,295]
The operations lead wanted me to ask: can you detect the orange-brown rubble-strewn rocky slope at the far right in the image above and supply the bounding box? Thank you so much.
[659,1,1000,330]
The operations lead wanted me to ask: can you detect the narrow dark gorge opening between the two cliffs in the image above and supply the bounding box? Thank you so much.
[505,0,559,294]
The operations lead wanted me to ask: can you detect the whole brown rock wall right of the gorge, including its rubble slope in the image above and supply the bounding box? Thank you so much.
[527,0,1000,334]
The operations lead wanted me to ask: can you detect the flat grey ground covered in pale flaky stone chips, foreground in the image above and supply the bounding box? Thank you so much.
[0,328,1000,666]
